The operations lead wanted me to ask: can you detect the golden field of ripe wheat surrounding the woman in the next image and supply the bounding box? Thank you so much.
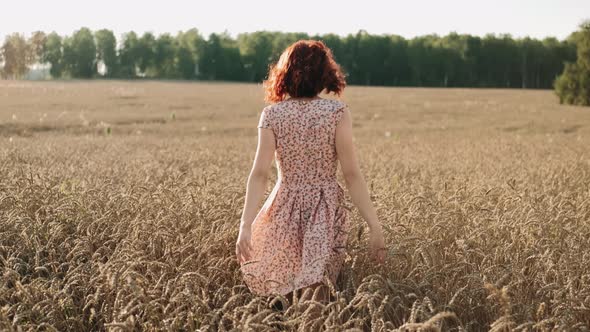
[0,81,590,331]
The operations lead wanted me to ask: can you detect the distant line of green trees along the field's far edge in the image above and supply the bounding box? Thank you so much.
[0,28,576,88]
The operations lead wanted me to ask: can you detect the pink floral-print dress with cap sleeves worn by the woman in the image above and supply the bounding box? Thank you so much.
[240,98,349,295]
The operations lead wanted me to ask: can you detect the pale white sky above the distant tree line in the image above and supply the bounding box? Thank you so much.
[0,0,590,40]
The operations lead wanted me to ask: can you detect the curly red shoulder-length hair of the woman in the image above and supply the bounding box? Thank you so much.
[263,40,346,103]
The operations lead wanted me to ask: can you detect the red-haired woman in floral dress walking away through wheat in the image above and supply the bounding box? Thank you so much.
[236,40,385,302]
